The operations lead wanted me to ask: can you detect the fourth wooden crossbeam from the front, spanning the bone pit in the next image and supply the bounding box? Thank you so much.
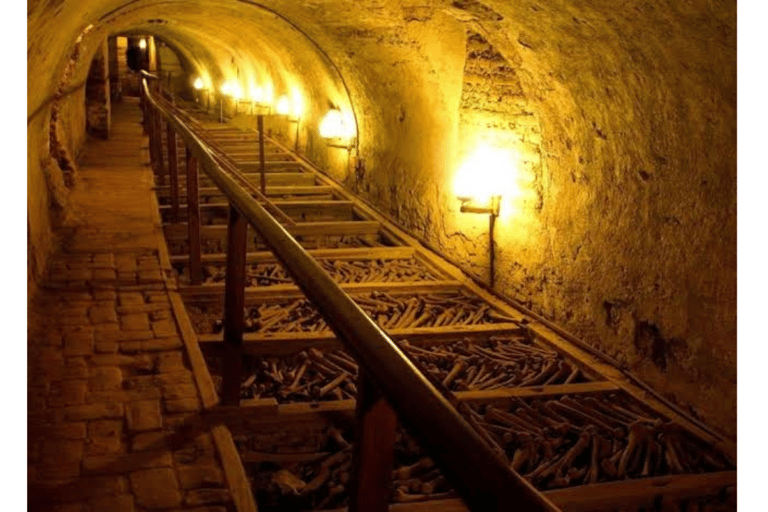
[180,281,464,304]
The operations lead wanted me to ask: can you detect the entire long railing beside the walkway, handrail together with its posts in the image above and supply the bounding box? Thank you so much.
[141,79,558,512]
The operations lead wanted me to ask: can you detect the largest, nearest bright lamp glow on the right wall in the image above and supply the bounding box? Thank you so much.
[453,143,520,209]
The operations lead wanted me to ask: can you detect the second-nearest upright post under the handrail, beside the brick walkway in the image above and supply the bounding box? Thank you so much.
[222,205,248,405]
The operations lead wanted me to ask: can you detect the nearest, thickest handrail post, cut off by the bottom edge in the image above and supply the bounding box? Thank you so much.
[349,369,397,512]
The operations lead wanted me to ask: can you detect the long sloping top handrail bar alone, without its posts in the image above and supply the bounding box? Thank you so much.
[143,81,559,512]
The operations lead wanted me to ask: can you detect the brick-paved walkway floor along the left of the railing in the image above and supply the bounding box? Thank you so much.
[27,103,234,512]
